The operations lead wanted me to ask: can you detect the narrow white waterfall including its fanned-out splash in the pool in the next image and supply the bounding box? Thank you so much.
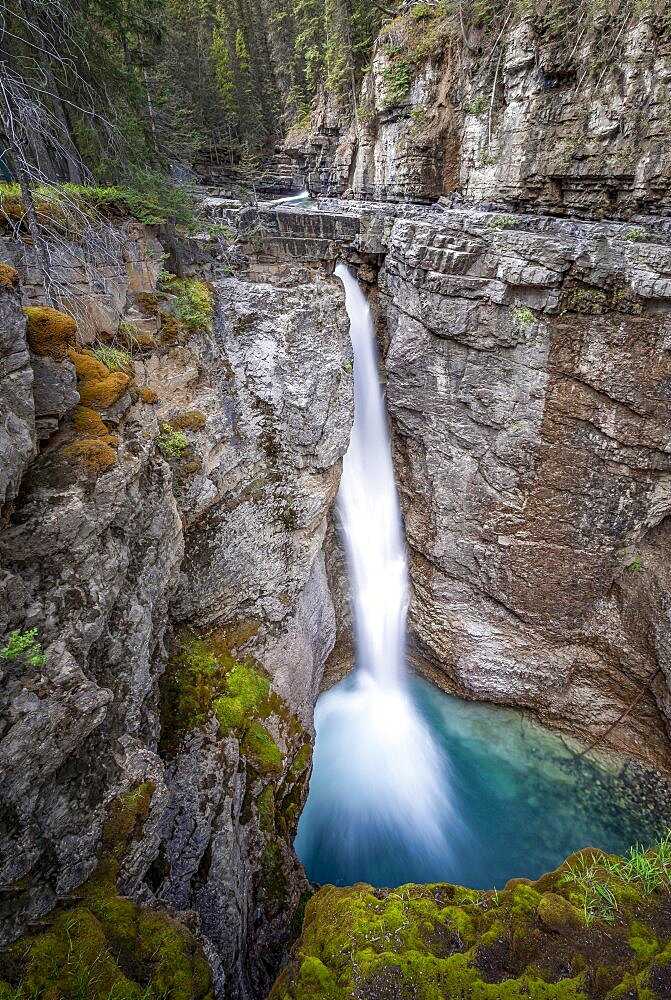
[296,264,454,885]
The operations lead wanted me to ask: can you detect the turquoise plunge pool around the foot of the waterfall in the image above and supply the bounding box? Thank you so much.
[295,676,671,889]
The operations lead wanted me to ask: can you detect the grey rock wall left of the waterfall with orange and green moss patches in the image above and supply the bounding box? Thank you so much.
[0,236,352,997]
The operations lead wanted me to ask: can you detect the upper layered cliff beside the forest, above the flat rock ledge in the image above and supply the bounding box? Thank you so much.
[300,8,671,218]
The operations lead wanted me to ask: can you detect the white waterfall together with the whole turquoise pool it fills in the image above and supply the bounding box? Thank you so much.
[295,265,671,889]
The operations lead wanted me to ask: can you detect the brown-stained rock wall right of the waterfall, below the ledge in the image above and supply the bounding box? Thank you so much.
[380,211,671,763]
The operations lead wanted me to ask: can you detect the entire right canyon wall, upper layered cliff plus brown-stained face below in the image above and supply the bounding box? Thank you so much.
[290,5,671,767]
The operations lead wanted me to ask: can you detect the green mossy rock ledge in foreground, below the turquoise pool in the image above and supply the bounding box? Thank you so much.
[271,852,671,1000]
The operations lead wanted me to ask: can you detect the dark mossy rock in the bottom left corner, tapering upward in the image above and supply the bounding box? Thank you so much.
[0,781,213,1000]
